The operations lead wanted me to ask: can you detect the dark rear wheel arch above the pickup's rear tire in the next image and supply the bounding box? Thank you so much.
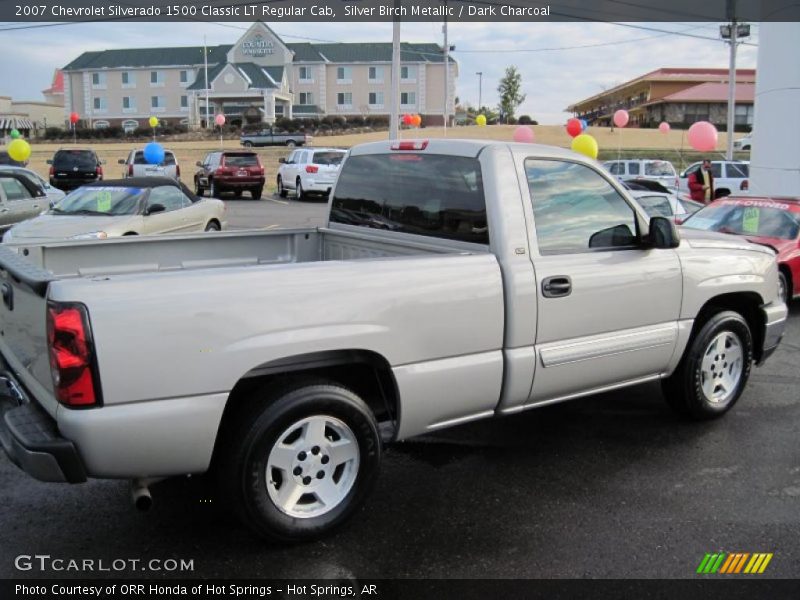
[215,349,400,453]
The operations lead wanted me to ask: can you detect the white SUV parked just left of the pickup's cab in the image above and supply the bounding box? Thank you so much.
[277,148,347,200]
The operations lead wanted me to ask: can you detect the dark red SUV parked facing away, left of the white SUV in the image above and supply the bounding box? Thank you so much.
[194,152,264,200]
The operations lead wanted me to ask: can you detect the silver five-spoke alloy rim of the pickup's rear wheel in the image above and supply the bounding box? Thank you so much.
[266,415,360,518]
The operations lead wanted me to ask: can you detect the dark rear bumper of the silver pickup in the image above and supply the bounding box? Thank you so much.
[0,368,86,483]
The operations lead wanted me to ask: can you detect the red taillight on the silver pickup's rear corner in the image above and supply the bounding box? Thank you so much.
[47,302,100,407]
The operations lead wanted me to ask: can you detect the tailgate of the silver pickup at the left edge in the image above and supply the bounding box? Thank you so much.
[0,246,57,416]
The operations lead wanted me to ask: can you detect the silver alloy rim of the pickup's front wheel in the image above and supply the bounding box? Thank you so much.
[700,331,744,405]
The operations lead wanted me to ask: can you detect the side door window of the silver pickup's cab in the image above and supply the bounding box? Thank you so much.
[525,159,637,254]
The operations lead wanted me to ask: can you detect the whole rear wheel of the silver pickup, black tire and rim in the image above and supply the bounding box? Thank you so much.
[215,381,381,542]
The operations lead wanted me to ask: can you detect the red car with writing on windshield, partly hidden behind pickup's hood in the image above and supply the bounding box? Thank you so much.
[683,196,800,303]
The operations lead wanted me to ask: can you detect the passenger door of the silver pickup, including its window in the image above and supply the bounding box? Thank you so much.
[518,158,682,404]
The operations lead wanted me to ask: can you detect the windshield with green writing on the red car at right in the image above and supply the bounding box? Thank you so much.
[684,200,800,240]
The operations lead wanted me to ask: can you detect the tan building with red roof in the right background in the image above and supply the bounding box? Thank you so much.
[567,68,756,131]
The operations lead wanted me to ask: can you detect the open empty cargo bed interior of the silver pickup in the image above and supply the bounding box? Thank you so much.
[13,228,474,279]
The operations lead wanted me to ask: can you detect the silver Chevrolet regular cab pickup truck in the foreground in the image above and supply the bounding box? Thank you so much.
[0,140,787,540]
